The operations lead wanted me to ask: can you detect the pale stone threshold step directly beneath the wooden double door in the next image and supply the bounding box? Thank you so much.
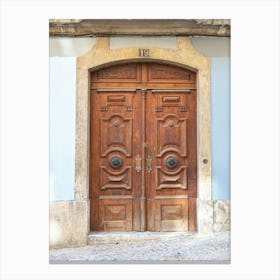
[88,231,197,245]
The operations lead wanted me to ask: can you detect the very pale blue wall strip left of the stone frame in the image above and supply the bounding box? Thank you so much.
[49,57,76,200]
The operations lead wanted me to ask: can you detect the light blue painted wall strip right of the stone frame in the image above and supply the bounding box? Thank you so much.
[211,57,230,199]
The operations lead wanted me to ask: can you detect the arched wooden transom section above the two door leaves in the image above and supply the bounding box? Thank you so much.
[91,61,196,89]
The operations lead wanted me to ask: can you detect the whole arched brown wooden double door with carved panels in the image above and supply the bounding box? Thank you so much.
[90,62,197,231]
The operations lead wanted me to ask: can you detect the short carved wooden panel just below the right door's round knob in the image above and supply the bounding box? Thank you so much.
[156,166,187,190]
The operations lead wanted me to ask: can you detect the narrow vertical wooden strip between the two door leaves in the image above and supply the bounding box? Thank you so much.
[140,89,147,231]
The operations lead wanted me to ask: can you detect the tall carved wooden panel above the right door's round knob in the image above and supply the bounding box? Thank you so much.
[156,114,187,157]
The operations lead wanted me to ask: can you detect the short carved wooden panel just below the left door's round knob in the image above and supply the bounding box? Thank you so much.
[99,166,132,190]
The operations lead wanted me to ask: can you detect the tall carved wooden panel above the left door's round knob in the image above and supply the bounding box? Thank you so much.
[100,114,132,157]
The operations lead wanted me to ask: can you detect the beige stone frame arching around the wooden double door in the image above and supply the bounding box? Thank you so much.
[75,37,213,236]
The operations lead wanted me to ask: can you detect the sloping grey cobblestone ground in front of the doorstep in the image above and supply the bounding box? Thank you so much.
[50,232,230,263]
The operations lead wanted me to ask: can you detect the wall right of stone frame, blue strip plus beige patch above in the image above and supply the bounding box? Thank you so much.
[191,37,230,199]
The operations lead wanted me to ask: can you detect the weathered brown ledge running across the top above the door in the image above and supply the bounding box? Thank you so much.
[49,19,230,37]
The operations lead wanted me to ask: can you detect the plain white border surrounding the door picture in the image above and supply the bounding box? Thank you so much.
[0,0,280,280]
